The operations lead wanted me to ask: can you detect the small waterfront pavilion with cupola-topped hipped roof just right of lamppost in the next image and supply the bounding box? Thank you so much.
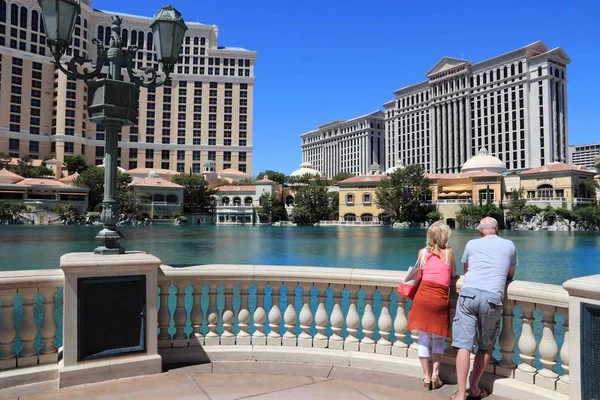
[131,171,184,218]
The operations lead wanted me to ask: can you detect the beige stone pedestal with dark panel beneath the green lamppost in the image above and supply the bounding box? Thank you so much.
[59,252,162,387]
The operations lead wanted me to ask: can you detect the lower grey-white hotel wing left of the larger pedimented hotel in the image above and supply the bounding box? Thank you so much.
[300,111,385,178]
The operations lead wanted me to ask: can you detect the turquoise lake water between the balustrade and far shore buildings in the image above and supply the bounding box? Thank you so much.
[0,225,600,284]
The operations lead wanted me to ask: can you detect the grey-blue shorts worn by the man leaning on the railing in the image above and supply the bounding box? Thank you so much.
[452,288,502,351]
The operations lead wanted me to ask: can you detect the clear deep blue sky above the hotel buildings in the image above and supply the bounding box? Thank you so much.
[92,0,600,173]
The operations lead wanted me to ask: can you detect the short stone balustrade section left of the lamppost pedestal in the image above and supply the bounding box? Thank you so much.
[0,270,63,371]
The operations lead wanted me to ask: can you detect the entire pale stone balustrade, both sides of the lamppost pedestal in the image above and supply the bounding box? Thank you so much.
[0,265,573,398]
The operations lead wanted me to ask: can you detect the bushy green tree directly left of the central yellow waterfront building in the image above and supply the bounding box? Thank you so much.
[292,181,331,224]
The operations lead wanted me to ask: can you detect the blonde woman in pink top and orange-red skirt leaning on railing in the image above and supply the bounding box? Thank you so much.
[408,221,456,390]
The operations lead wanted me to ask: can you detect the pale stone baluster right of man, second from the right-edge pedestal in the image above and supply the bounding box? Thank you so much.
[535,304,558,390]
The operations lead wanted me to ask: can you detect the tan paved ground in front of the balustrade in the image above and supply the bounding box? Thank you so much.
[19,370,501,400]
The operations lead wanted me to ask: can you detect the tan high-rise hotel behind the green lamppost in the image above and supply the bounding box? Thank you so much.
[0,0,256,174]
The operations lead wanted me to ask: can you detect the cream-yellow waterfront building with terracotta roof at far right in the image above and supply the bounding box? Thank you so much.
[519,163,597,210]
